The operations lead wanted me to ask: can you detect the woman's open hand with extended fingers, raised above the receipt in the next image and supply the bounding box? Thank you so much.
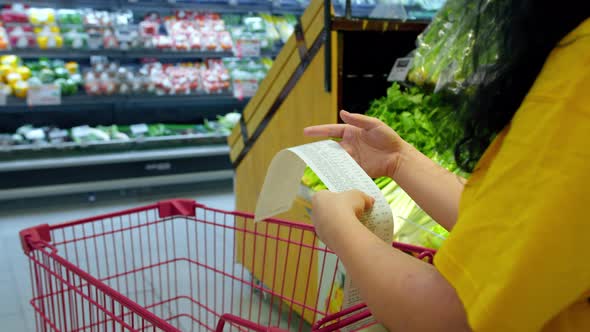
[303,111,407,178]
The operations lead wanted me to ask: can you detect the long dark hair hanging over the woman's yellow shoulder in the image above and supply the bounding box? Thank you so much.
[455,0,590,172]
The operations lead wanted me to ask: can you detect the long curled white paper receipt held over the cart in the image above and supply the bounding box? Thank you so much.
[255,140,393,325]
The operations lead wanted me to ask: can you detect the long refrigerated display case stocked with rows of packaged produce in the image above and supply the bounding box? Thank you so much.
[0,0,307,201]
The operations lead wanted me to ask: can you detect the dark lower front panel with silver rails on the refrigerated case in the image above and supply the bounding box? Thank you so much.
[0,144,232,200]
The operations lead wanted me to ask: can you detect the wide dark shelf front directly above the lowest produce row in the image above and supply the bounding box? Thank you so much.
[0,93,250,132]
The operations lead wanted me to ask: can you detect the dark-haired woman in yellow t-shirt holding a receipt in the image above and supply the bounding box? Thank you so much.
[305,0,590,332]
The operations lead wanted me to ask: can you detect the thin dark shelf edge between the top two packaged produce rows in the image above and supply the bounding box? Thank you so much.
[0,47,280,60]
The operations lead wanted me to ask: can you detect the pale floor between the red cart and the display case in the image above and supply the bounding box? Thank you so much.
[0,184,234,332]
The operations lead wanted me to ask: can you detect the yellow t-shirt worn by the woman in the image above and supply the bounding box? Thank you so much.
[434,19,590,332]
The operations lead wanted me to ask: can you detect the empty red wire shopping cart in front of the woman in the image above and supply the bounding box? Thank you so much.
[20,200,434,332]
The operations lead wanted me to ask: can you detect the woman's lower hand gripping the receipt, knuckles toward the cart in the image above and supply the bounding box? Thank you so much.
[311,190,375,250]
